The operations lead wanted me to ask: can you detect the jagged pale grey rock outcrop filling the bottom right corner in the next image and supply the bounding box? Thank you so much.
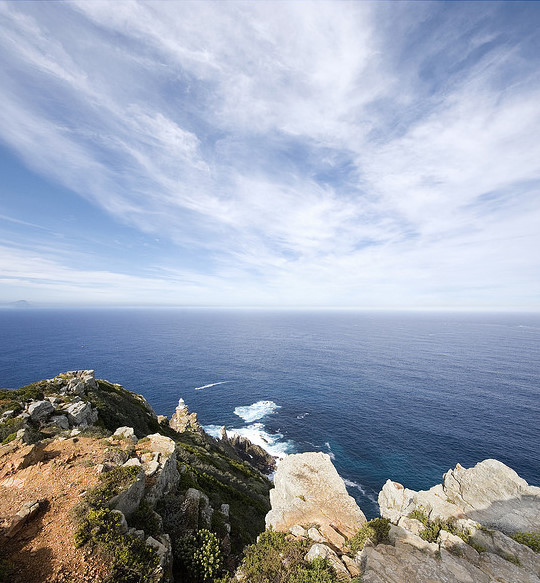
[362,460,540,583]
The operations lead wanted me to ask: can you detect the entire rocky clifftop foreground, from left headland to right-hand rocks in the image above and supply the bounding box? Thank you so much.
[0,371,540,583]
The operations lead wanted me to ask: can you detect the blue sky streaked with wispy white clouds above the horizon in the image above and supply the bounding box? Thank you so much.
[0,0,540,310]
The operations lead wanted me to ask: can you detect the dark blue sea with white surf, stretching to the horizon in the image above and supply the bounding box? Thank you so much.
[0,309,540,516]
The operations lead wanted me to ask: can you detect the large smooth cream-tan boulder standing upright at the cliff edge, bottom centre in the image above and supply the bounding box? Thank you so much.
[266,452,366,538]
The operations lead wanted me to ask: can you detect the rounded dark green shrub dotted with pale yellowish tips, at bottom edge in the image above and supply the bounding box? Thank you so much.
[174,529,223,583]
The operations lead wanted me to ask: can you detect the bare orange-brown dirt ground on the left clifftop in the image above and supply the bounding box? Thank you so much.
[0,438,113,583]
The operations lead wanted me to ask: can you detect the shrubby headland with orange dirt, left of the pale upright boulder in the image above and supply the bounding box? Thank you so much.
[0,371,273,583]
